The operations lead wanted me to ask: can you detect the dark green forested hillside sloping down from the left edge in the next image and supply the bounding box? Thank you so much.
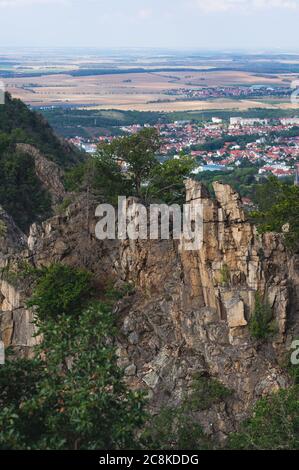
[0,94,82,232]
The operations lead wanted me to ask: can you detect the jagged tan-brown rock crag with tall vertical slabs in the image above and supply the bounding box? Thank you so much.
[2,181,299,440]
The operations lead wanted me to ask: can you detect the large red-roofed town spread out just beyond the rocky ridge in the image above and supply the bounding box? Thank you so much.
[69,117,299,185]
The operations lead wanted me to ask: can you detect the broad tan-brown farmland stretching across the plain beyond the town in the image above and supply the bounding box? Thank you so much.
[3,71,298,111]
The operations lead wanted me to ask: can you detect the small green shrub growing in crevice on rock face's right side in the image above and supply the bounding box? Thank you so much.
[249,292,274,340]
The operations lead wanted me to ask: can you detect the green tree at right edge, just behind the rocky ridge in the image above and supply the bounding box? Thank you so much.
[252,176,299,251]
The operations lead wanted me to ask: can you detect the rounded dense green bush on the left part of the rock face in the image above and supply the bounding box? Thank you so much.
[28,264,91,320]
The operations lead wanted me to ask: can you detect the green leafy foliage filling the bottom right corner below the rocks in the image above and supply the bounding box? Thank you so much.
[228,385,299,450]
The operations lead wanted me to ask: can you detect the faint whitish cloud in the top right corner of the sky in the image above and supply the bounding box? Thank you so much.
[195,0,299,12]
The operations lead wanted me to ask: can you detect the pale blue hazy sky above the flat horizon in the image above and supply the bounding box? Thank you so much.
[0,0,299,52]
